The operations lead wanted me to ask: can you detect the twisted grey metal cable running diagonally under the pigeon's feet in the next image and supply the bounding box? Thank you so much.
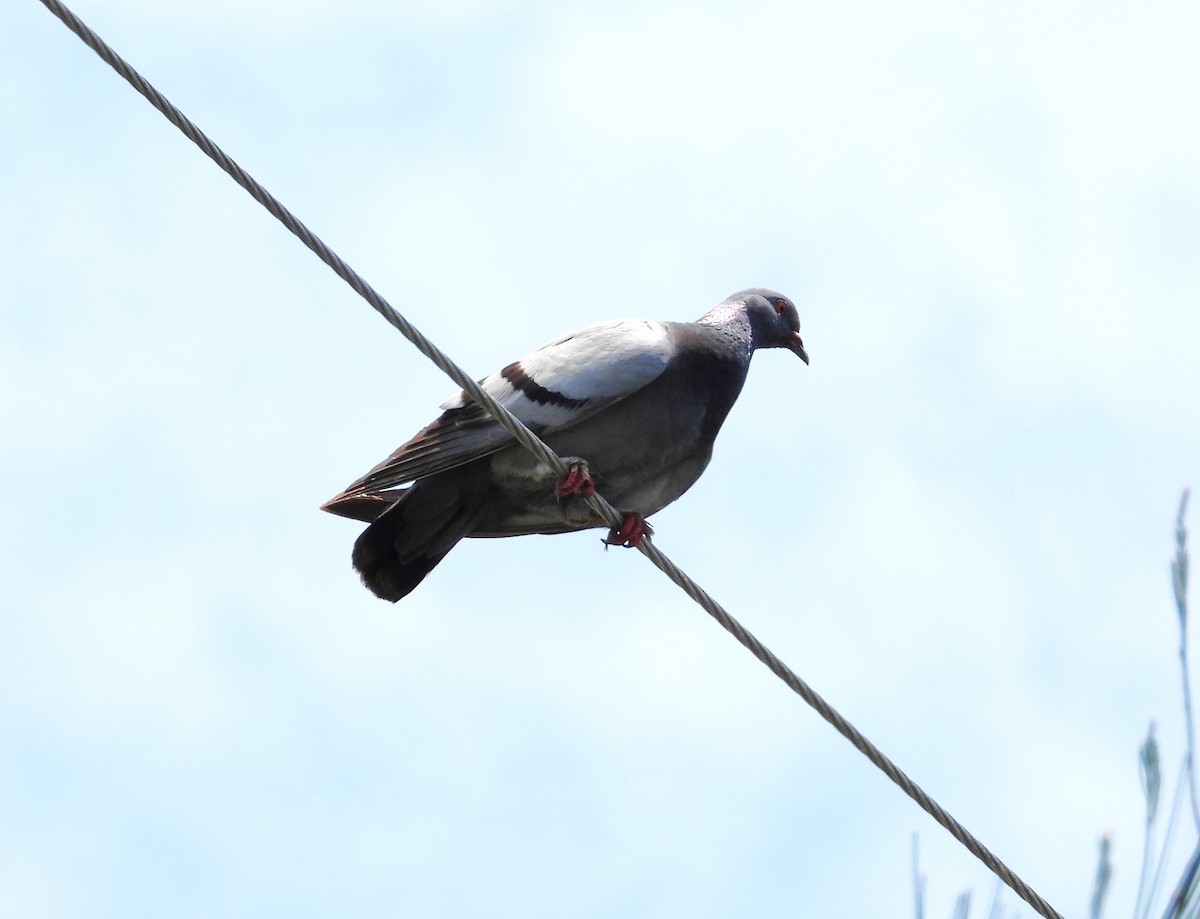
[32,0,1063,919]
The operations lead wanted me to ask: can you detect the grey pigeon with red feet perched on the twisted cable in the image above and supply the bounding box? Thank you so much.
[322,288,809,602]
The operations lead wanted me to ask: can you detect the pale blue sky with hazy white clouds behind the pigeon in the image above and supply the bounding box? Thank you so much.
[0,0,1200,919]
